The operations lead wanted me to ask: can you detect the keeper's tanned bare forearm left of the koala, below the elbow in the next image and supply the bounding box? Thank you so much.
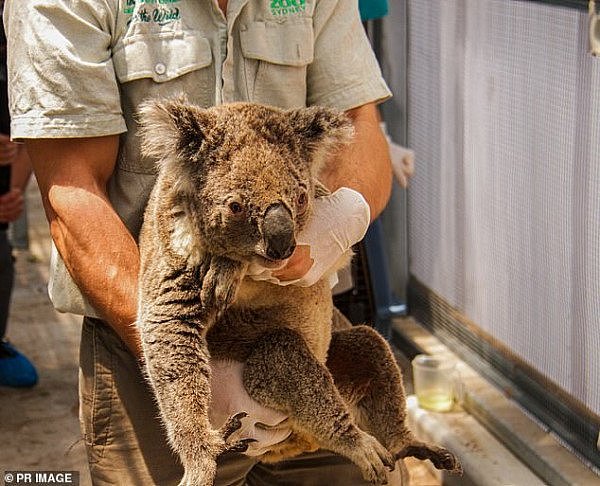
[49,186,141,357]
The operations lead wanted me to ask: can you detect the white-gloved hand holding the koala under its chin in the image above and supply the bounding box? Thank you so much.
[248,187,370,287]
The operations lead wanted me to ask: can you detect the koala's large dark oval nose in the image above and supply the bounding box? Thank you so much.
[263,204,296,260]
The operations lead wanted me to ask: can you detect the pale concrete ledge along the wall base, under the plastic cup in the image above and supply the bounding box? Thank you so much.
[393,318,600,486]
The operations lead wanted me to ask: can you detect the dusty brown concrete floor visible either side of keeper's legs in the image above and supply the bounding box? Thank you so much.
[0,183,440,486]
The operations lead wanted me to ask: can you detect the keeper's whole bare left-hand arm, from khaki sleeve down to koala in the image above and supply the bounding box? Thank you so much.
[26,135,141,358]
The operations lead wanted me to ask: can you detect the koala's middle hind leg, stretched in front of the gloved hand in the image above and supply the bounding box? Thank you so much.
[244,329,394,484]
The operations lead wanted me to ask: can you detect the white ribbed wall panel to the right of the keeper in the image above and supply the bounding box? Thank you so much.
[408,0,600,414]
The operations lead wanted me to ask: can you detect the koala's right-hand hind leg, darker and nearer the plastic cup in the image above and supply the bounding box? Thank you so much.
[327,326,461,472]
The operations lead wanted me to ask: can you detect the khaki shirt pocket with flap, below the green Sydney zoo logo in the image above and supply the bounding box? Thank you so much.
[240,18,314,108]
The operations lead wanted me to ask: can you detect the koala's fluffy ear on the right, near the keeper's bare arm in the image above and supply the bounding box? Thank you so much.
[290,106,354,173]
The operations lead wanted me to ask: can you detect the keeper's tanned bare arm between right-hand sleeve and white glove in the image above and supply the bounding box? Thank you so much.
[320,104,392,220]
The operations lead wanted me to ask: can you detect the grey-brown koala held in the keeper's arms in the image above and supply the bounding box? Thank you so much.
[137,99,460,486]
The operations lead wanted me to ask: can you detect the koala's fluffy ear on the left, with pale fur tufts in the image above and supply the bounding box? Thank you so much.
[138,98,213,164]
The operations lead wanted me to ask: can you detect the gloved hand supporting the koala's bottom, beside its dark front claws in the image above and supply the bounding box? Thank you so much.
[208,360,291,456]
